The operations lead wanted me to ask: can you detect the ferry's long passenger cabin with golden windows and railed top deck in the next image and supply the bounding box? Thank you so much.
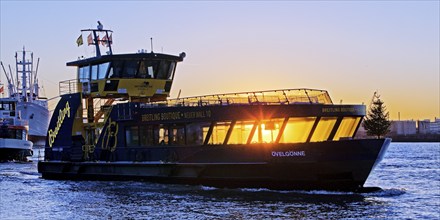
[113,89,365,150]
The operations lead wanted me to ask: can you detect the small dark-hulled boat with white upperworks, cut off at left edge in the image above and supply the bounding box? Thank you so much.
[0,98,33,161]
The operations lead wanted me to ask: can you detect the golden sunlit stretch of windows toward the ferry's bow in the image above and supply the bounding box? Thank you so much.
[203,117,360,144]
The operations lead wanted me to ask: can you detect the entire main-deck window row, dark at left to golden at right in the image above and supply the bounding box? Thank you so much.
[125,117,361,147]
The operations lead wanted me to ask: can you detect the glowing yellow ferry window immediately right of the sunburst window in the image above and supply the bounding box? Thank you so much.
[280,117,316,143]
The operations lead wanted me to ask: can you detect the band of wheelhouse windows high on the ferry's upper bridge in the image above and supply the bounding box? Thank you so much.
[78,60,176,82]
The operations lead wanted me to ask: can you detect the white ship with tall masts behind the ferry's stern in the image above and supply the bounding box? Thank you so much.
[2,48,50,143]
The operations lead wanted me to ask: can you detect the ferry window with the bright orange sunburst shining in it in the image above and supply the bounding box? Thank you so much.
[251,118,284,143]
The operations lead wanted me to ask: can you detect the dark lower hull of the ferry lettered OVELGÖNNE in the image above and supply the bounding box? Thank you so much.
[38,139,390,191]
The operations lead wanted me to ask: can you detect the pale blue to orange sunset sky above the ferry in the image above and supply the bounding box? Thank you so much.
[0,1,440,120]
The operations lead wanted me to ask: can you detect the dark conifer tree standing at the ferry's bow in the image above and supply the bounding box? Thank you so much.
[363,93,391,138]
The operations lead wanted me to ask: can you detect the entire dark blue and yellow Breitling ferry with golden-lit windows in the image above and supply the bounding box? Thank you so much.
[38,22,390,191]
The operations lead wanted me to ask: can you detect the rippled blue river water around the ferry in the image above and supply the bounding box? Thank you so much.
[0,143,440,220]
